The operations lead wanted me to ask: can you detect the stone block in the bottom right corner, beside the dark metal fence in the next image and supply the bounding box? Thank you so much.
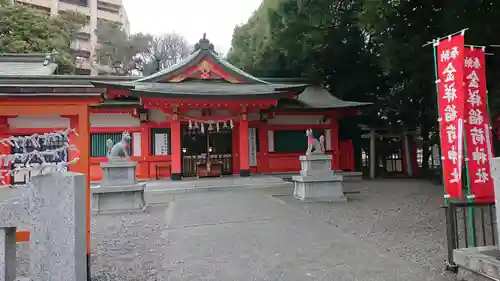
[453,246,500,281]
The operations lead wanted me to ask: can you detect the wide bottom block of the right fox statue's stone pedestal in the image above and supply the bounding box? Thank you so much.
[292,175,347,202]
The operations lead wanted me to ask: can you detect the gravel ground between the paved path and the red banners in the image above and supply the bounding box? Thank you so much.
[277,180,456,276]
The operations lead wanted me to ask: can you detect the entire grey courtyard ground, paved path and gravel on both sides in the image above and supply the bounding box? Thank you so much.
[92,181,450,281]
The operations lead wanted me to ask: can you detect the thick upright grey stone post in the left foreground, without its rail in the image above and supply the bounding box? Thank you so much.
[29,172,87,281]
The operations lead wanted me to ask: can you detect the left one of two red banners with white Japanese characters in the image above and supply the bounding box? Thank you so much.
[436,34,465,198]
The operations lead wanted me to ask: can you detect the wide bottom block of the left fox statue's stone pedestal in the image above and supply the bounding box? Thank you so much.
[92,183,147,213]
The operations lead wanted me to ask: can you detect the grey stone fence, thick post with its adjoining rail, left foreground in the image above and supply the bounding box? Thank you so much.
[0,172,87,281]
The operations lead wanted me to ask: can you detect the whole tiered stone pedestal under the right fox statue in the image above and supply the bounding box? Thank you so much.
[292,154,346,202]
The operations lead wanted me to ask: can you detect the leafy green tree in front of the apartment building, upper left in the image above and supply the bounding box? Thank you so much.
[0,5,87,73]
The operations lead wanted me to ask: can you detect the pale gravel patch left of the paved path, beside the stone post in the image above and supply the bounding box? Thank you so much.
[91,205,168,281]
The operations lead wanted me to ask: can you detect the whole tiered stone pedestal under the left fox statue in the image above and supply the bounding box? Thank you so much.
[92,158,147,213]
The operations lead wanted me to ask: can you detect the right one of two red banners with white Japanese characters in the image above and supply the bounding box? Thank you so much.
[463,48,495,202]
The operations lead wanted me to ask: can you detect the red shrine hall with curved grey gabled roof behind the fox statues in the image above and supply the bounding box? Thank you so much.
[92,35,372,180]
